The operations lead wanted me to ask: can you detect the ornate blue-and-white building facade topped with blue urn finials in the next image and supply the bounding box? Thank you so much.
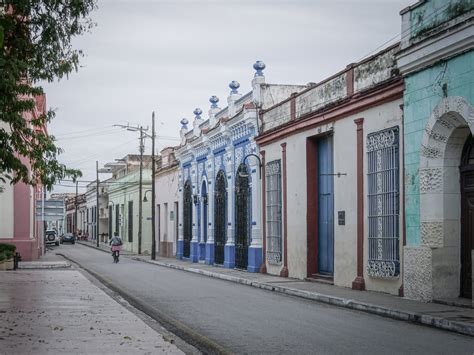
[176,61,305,272]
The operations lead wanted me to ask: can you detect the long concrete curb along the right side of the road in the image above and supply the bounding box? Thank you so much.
[132,257,474,336]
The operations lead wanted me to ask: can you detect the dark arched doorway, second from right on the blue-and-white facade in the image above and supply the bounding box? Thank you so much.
[214,170,227,264]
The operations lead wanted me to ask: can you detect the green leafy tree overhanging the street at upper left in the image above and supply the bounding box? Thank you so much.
[0,0,96,189]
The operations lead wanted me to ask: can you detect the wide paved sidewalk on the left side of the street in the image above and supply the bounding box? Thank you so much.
[0,254,182,354]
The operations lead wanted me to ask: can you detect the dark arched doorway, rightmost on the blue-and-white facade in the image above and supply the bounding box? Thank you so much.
[235,164,251,269]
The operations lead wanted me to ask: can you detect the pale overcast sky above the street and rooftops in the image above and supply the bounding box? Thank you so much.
[44,0,416,192]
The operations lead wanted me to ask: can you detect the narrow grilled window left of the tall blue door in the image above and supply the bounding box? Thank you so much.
[265,160,282,264]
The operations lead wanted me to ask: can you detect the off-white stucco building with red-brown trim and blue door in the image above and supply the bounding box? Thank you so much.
[256,45,404,294]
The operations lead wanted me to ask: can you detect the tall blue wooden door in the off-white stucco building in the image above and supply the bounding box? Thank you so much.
[318,136,334,275]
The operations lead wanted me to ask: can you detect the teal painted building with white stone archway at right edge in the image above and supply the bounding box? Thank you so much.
[397,0,474,301]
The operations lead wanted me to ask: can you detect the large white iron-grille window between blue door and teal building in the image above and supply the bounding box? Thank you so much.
[367,127,400,278]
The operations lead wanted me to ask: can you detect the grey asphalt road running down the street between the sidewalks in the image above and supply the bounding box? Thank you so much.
[55,244,474,354]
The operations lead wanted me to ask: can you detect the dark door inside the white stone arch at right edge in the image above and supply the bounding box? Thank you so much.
[459,135,474,298]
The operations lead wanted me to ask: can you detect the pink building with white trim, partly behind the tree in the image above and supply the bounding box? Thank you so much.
[0,95,46,261]
